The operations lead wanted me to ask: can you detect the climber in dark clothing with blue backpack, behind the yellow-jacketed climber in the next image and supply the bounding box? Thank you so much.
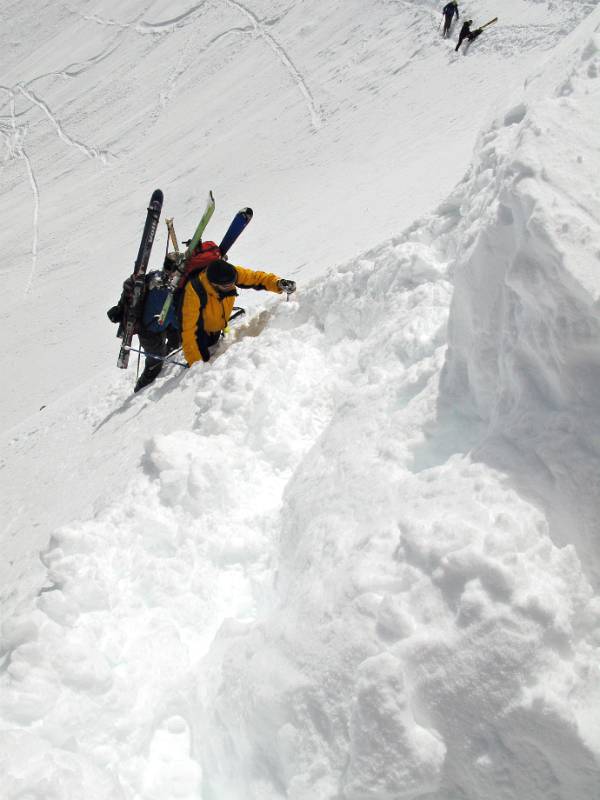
[107,253,181,392]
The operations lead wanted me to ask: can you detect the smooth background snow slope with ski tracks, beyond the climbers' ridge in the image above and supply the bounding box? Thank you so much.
[0,0,589,429]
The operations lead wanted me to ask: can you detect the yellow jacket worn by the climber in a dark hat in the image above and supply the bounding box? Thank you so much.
[181,267,281,366]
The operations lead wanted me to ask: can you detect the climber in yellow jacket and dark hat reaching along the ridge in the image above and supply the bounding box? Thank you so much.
[181,242,296,366]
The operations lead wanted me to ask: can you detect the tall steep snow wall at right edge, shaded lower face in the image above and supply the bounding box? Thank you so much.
[441,6,600,585]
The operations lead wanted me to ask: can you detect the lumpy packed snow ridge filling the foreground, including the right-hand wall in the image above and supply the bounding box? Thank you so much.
[0,4,600,800]
